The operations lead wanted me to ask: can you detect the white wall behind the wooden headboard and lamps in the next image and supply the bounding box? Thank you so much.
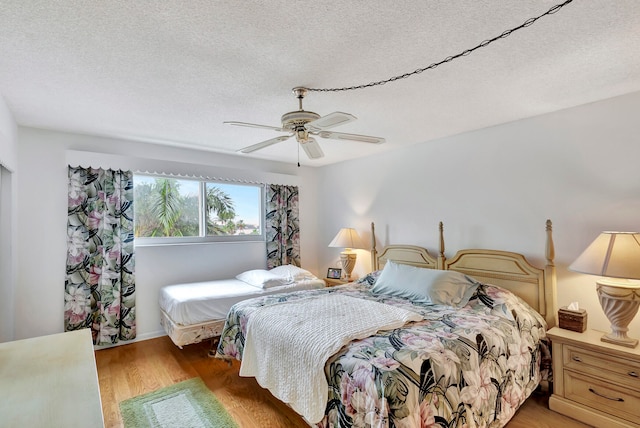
[318,92,640,337]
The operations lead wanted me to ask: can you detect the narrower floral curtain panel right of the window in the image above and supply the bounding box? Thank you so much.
[265,184,300,269]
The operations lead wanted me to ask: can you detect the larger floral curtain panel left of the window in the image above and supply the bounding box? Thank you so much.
[64,166,136,345]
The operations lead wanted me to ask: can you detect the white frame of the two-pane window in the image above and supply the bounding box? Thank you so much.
[133,172,266,246]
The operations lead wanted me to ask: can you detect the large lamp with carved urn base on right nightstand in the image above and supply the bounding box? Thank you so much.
[569,232,640,348]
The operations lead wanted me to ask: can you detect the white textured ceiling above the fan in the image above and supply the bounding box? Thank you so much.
[0,0,640,166]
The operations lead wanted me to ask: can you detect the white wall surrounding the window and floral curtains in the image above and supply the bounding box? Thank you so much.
[15,128,317,339]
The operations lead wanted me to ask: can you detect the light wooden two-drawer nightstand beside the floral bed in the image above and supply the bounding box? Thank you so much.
[547,327,640,428]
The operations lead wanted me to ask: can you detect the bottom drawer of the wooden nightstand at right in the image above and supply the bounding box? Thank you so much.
[564,370,640,421]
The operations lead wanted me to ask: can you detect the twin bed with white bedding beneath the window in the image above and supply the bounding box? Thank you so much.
[159,265,325,348]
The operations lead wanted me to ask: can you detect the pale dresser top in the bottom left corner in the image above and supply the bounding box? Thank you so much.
[0,329,104,428]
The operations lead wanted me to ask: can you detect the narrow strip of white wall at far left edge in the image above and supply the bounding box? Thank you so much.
[0,96,18,342]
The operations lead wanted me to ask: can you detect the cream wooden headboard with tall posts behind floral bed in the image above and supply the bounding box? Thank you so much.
[371,220,557,328]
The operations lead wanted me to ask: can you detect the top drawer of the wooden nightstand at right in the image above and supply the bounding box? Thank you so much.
[562,345,640,392]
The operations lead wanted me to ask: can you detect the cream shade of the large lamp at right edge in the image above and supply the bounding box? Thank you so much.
[569,232,640,279]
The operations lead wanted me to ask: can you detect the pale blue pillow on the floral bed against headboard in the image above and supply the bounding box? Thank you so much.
[371,261,478,308]
